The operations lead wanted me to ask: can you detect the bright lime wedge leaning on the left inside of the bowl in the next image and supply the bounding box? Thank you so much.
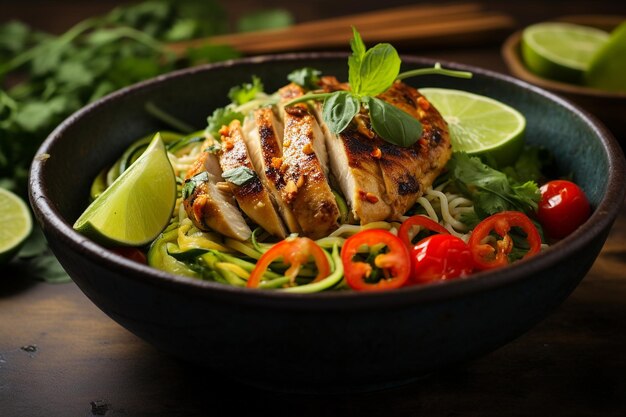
[74,133,176,246]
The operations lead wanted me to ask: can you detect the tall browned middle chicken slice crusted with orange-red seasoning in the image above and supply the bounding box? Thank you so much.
[279,83,339,239]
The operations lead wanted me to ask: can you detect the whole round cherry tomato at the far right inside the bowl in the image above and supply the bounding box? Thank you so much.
[537,180,591,239]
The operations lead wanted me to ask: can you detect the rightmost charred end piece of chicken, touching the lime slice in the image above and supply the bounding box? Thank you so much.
[378,81,452,218]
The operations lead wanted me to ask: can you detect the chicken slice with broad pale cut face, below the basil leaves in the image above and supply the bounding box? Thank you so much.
[315,103,391,224]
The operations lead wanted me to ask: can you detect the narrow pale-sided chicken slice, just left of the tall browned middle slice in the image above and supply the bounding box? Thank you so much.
[243,107,301,233]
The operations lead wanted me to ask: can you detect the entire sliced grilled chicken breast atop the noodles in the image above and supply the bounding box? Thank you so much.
[184,77,452,240]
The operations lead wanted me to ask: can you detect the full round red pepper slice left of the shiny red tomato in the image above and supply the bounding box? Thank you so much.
[341,229,411,291]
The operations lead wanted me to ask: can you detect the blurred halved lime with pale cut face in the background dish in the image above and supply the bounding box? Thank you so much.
[522,22,609,84]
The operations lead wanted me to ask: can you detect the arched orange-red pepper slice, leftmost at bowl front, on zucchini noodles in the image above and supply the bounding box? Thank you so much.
[247,237,330,288]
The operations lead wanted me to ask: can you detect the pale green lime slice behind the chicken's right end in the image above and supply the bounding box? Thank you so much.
[420,88,526,166]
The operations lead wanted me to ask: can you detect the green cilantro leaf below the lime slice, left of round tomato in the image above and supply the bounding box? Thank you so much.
[448,152,540,219]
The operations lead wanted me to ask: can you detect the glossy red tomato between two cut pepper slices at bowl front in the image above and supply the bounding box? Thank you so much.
[411,234,474,283]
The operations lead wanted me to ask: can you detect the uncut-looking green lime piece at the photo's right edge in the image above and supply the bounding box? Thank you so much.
[585,22,626,91]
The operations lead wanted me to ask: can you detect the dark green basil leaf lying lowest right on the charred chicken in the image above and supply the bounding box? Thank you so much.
[367,97,422,148]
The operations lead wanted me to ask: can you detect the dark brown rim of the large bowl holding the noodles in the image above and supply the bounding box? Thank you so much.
[29,52,626,311]
